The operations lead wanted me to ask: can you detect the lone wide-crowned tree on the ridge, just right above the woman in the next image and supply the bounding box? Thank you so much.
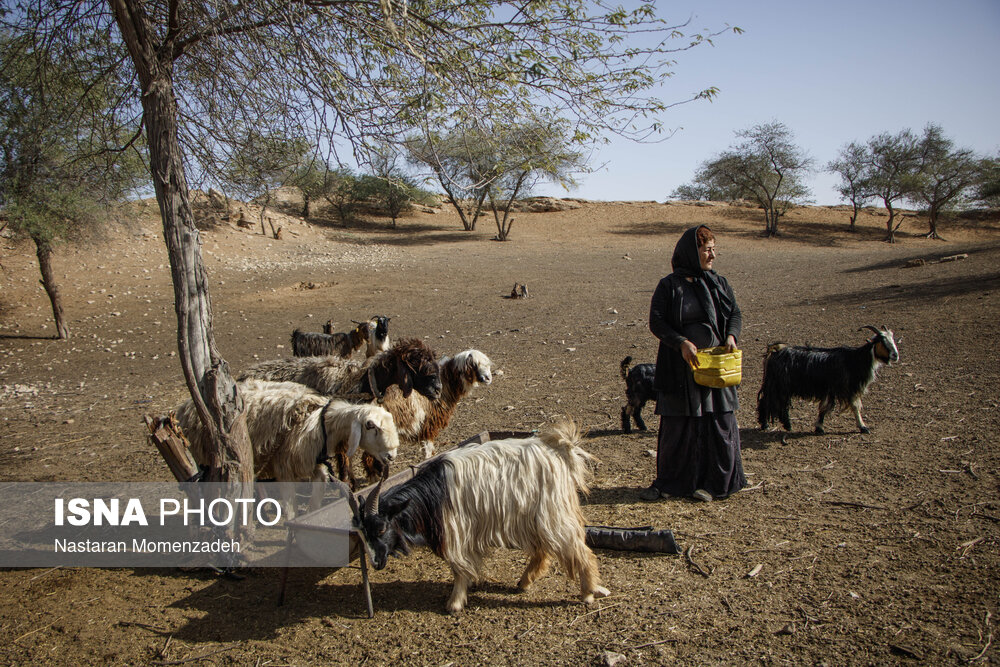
[695,121,813,236]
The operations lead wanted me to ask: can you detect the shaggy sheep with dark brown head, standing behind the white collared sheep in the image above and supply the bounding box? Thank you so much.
[238,338,441,400]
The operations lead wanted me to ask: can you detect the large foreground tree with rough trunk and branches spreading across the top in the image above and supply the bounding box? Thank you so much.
[0,0,740,481]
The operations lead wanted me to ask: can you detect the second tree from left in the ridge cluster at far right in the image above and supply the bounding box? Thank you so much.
[864,129,920,243]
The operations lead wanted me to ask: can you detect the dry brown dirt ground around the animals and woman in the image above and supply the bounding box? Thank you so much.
[0,196,1000,665]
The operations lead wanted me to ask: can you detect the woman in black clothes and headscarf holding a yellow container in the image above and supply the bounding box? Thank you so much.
[639,225,746,501]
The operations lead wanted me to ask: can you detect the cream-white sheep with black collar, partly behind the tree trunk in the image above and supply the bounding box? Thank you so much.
[176,380,399,487]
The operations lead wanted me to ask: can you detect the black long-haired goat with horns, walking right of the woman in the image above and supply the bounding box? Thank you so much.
[757,326,899,434]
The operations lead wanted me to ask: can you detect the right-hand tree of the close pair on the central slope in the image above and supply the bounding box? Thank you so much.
[487,119,586,241]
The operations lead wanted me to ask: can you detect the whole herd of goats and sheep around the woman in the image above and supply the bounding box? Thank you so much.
[176,317,899,613]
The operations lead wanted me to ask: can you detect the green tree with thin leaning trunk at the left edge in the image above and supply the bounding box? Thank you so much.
[0,34,146,339]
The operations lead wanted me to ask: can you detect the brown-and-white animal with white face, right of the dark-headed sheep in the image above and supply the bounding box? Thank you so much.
[362,350,493,480]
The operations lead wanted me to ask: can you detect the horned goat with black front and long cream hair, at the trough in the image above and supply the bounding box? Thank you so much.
[358,421,610,613]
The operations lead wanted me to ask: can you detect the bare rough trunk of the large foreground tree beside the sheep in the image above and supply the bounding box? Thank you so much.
[109,0,253,483]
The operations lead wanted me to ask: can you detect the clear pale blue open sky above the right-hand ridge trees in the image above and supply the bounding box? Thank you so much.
[535,0,1000,205]
